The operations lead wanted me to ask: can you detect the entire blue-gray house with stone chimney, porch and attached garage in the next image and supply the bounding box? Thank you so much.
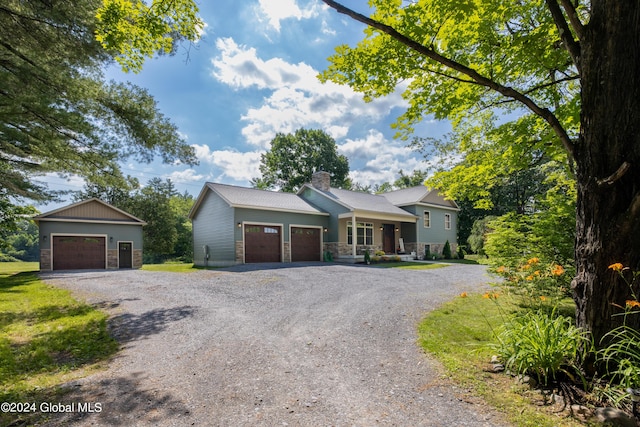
[189,172,459,266]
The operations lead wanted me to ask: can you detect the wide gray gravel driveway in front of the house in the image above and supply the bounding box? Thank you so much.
[41,263,507,426]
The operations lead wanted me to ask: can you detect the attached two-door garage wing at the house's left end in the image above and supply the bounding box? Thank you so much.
[189,182,331,267]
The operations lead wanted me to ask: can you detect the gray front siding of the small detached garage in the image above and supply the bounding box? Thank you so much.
[40,221,142,249]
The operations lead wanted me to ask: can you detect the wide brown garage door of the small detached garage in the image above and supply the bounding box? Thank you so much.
[53,236,106,270]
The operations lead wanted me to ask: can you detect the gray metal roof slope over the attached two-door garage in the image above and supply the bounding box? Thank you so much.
[207,182,327,215]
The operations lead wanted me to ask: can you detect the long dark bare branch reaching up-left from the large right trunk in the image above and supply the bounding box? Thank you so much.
[322,0,574,157]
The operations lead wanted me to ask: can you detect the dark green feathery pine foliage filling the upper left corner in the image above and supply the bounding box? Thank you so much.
[0,0,196,229]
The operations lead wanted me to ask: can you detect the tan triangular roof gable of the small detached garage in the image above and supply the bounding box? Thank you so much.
[33,198,146,225]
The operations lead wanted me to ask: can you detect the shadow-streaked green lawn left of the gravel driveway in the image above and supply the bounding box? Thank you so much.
[0,263,119,425]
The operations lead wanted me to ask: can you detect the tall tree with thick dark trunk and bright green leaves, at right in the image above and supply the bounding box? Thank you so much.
[323,0,640,352]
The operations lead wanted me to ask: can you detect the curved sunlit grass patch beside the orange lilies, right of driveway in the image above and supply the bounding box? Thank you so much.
[418,294,582,427]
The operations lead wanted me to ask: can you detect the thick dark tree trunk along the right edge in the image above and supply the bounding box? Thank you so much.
[572,0,640,347]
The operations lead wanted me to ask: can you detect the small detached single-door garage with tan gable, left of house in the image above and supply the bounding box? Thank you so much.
[34,199,146,271]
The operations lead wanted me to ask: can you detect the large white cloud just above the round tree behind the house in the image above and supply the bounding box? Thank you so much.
[212,38,406,149]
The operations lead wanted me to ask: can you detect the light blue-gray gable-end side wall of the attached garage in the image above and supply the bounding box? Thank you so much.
[192,191,237,266]
